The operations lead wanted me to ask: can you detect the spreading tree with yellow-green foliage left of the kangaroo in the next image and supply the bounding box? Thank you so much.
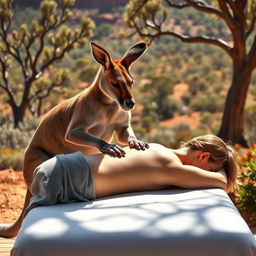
[0,0,94,127]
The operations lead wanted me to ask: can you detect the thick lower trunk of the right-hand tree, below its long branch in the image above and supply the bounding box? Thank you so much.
[218,63,252,147]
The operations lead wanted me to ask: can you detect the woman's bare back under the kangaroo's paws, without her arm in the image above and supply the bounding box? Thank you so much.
[86,144,181,197]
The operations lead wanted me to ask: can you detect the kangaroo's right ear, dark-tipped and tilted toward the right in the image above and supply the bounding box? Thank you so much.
[121,43,147,69]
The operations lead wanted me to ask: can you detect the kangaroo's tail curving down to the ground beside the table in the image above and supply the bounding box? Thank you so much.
[0,189,32,238]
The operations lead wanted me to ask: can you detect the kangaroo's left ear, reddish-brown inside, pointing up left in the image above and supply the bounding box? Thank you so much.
[91,42,113,69]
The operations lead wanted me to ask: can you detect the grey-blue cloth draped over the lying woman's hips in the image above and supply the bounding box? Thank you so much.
[24,152,95,216]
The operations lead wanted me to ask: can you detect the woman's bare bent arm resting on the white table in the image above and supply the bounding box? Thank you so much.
[166,164,227,190]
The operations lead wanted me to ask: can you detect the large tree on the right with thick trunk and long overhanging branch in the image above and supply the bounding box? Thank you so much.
[126,0,256,146]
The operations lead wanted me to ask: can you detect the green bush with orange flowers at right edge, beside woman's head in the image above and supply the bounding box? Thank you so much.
[236,145,256,216]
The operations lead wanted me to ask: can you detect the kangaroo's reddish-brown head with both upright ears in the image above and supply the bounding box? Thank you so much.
[91,42,147,111]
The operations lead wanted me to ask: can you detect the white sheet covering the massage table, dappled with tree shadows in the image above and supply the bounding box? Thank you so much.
[11,189,256,256]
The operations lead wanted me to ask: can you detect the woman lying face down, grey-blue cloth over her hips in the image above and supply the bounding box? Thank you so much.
[25,135,238,214]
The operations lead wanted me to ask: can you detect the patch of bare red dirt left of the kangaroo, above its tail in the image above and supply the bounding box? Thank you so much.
[0,169,26,223]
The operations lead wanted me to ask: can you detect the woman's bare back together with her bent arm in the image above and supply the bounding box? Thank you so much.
[86,144,226,197]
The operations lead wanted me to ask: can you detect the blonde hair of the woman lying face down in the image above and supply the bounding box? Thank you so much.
[182,134,239,192]
